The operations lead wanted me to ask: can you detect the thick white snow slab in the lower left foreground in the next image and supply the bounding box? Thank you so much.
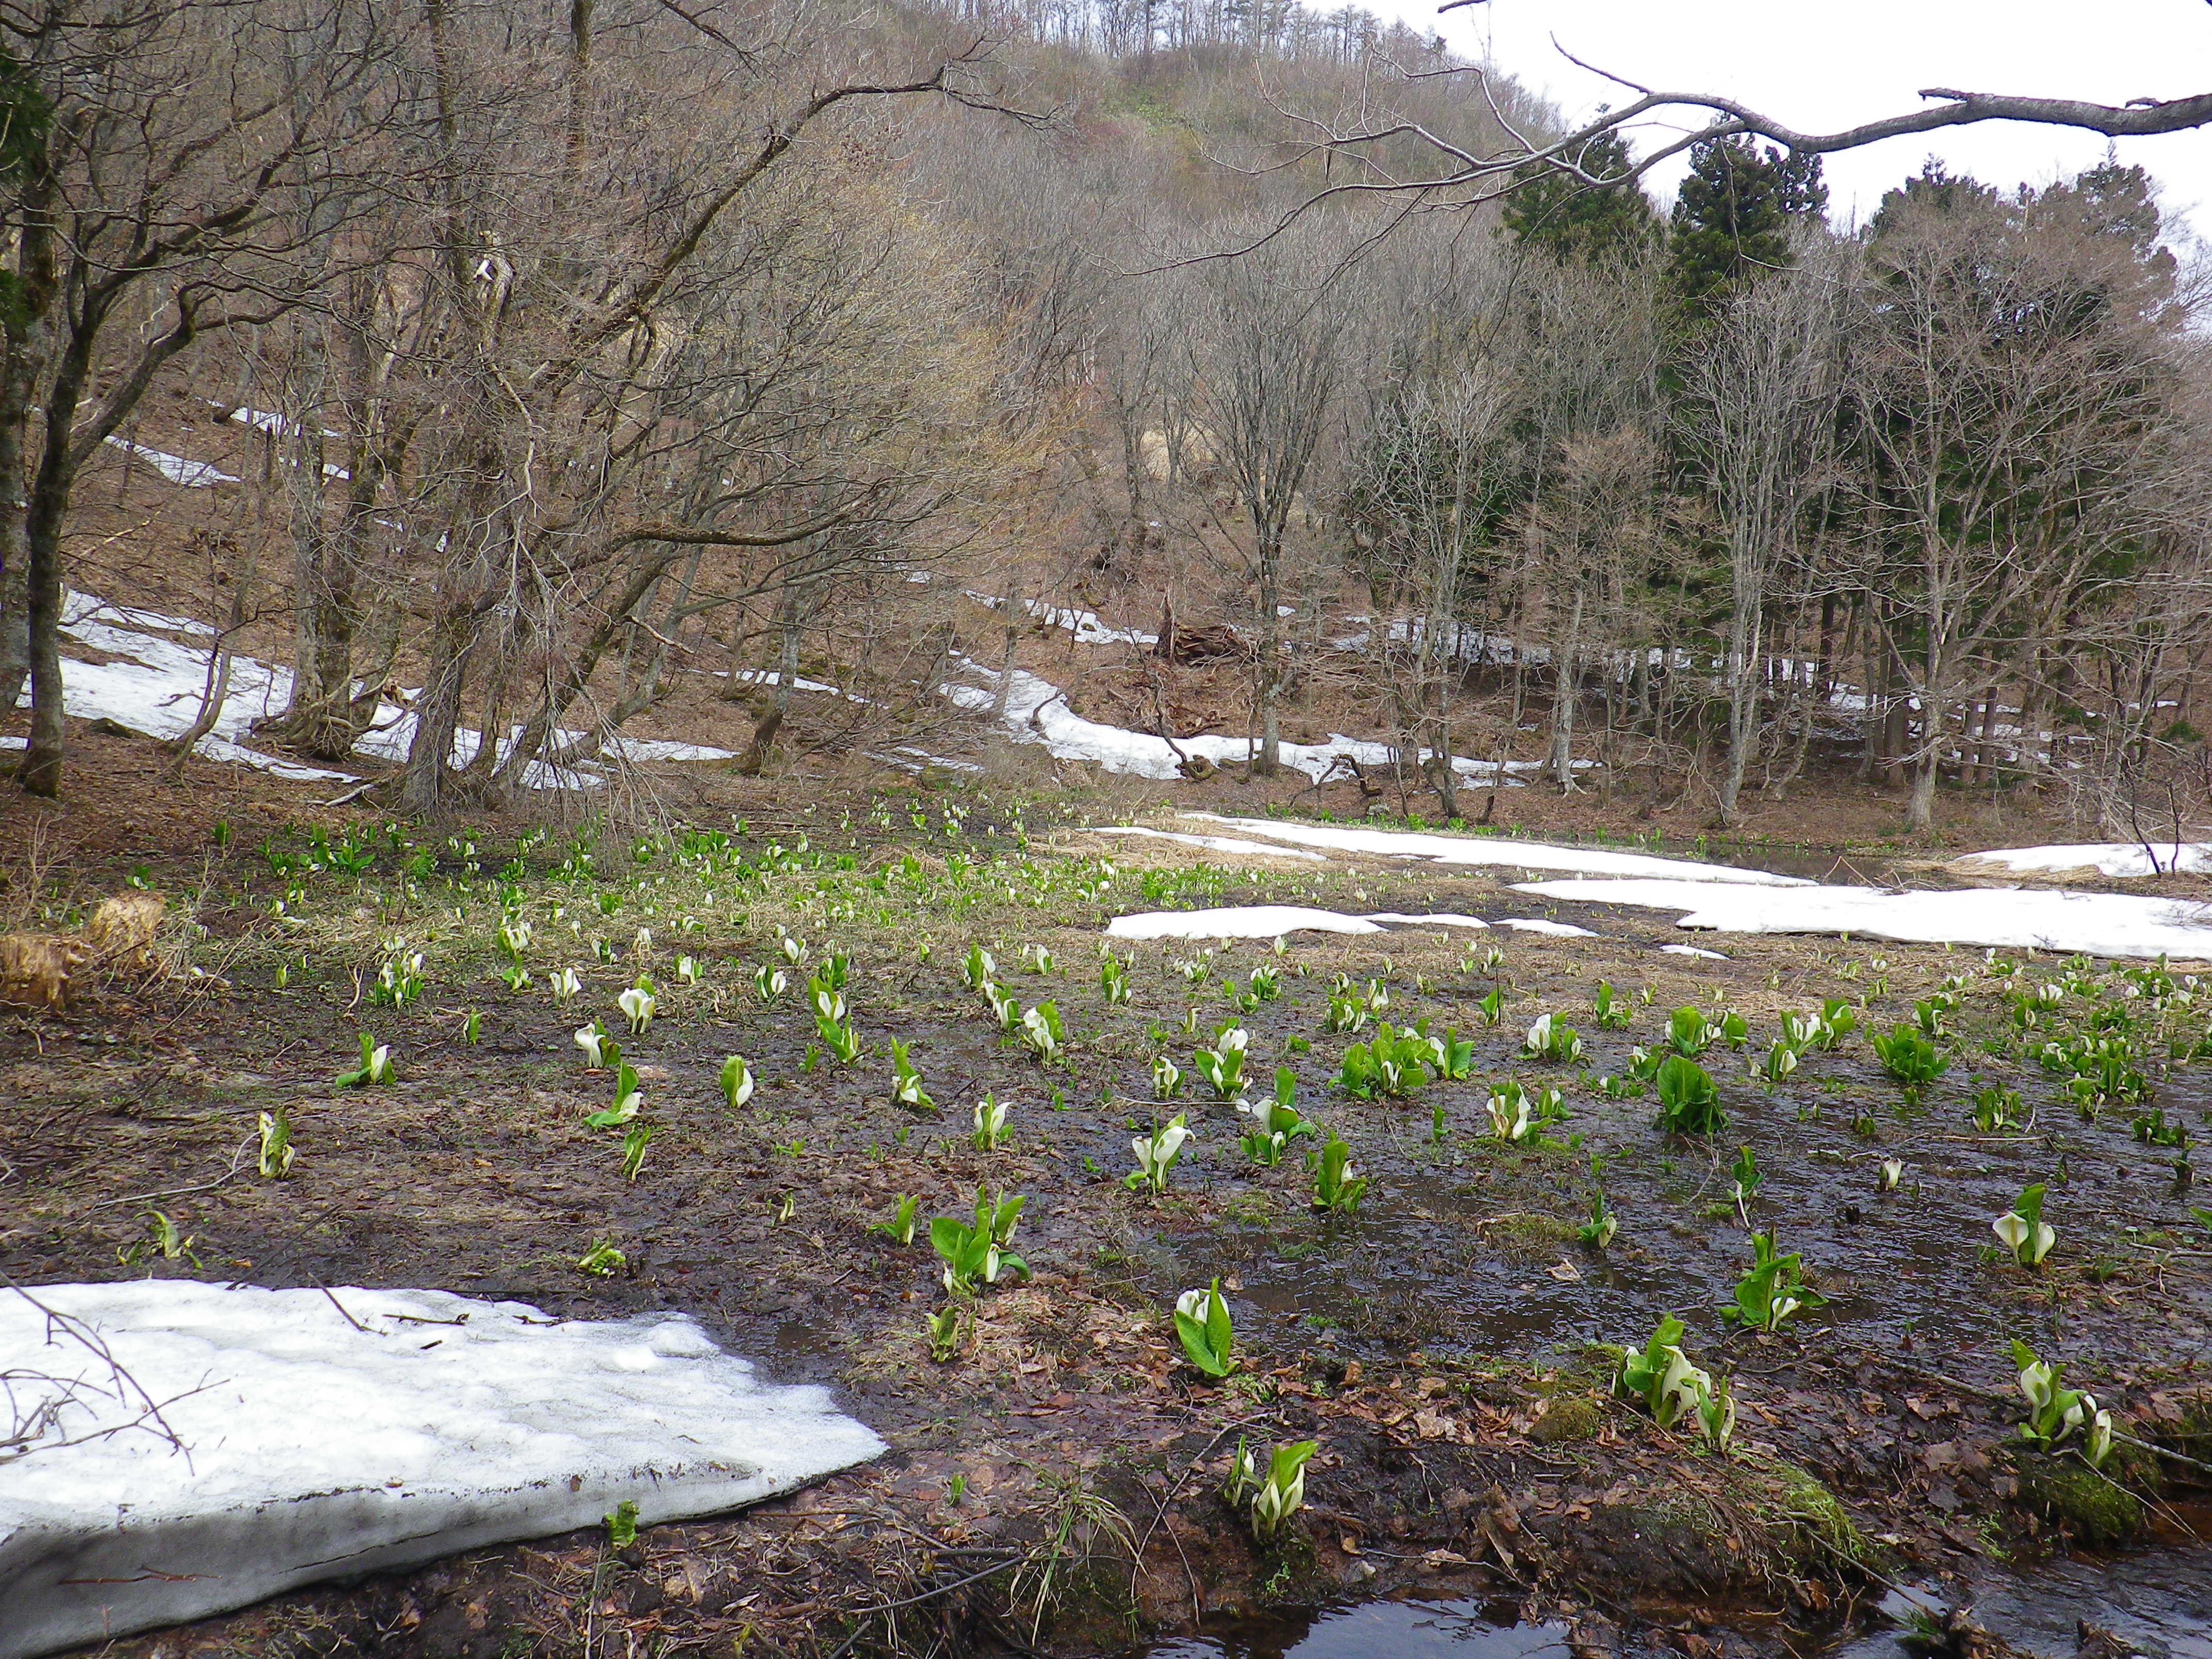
[0,1281,883,1659]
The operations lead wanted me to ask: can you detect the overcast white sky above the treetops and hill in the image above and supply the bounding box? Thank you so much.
[1369,0,2212,239]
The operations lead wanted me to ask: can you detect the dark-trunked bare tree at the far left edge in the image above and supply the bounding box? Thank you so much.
[0,0,389,796]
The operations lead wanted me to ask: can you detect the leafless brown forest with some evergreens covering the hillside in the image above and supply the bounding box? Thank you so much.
[0,0,2212,836]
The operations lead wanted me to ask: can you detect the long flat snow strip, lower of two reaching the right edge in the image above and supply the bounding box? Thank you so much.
[1513,881,2212,958]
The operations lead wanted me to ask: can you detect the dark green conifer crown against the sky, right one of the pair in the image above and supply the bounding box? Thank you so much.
[1668,133,1827,316]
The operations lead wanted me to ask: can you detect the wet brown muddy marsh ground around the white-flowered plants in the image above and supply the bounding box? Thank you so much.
[0,814,2212,1659]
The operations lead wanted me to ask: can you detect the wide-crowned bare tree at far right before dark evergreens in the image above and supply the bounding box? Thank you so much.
[1849,172,2181,829]
